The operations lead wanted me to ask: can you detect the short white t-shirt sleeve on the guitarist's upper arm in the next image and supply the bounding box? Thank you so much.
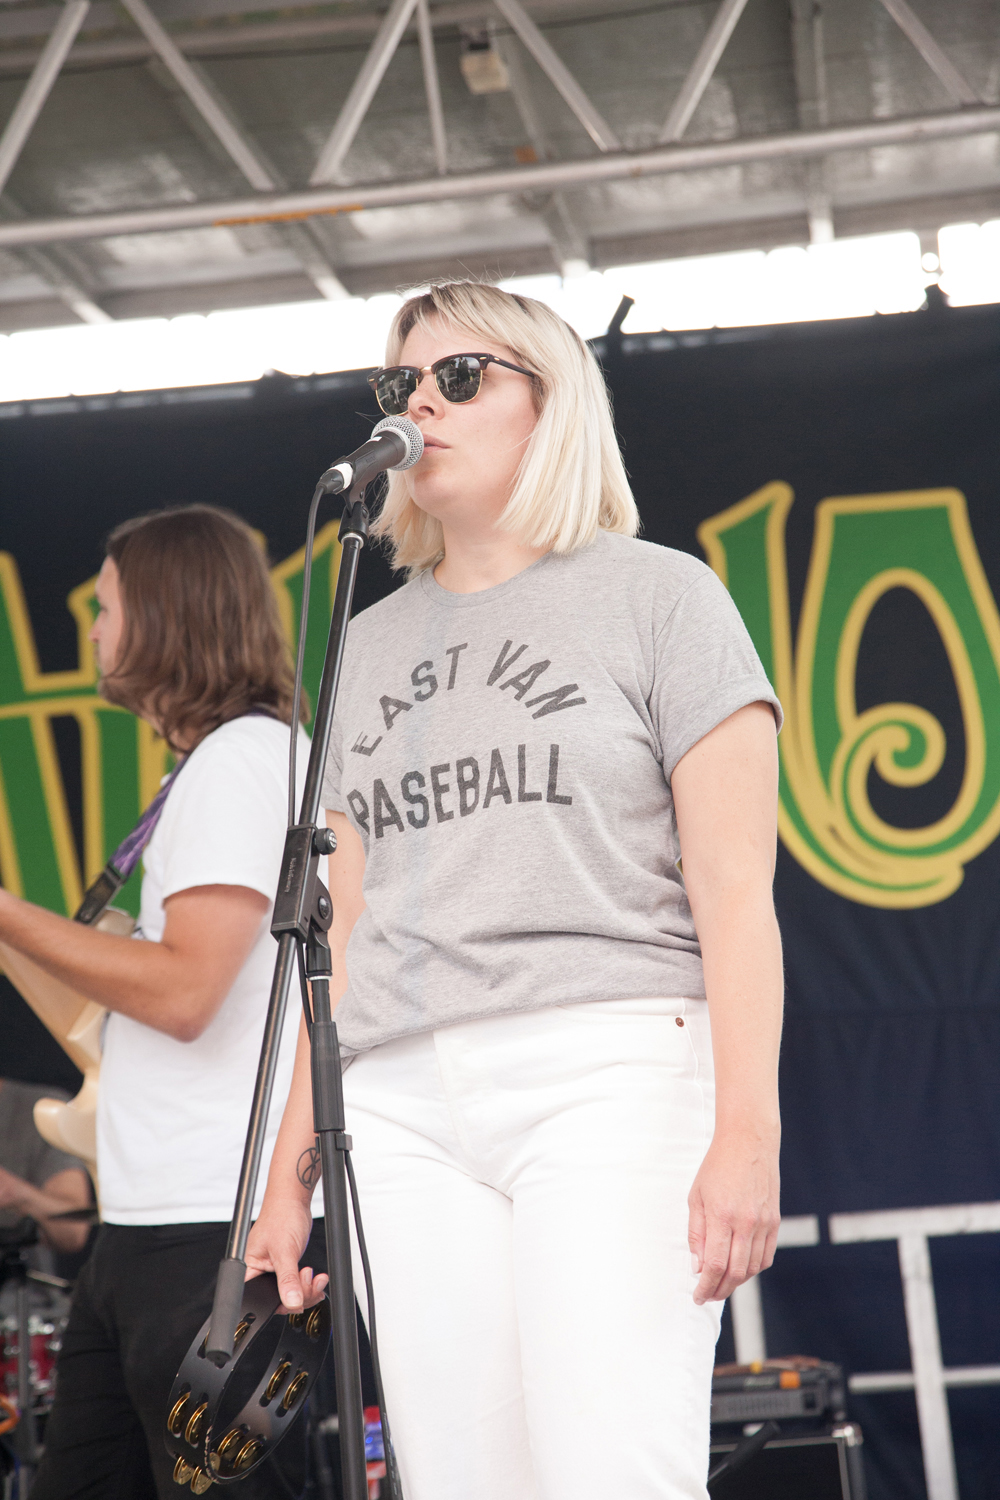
[157,741,286,900]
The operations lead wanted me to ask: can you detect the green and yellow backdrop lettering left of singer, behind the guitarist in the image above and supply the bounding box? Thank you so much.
[0,522,340,915]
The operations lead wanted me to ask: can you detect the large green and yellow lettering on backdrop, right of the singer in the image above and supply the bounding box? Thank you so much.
[699,483,1000,908]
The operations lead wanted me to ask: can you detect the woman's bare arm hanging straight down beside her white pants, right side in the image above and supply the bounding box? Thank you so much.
[672,704,783,1302]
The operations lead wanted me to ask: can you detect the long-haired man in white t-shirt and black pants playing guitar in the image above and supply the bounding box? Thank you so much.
[0,506,325,1500]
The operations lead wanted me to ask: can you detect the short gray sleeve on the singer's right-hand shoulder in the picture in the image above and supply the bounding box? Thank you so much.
[649,569,783,780]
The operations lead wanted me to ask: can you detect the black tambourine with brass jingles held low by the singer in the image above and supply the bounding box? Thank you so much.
[163,1275,330,1496]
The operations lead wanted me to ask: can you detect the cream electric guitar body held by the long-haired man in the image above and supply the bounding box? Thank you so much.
[0,906,135,1185]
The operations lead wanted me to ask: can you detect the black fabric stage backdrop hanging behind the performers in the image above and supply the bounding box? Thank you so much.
[0,308,1000,1500]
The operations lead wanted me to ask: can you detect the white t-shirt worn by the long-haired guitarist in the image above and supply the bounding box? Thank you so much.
[97,716,325,1224]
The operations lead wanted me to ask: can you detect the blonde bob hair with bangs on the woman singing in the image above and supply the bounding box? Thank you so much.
[372,282,639,578]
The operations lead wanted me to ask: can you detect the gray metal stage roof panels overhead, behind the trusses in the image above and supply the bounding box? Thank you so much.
[0,0,1000,332]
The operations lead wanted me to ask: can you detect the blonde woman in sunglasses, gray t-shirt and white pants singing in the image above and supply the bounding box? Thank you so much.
[247,284,781,1500]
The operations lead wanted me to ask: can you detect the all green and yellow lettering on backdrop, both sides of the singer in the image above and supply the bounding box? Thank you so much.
[0,483,1000,914]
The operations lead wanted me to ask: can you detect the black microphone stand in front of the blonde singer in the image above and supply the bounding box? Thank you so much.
[205,485,369,1500]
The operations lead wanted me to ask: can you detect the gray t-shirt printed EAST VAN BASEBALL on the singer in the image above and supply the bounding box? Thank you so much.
[324,533,781,1058]
